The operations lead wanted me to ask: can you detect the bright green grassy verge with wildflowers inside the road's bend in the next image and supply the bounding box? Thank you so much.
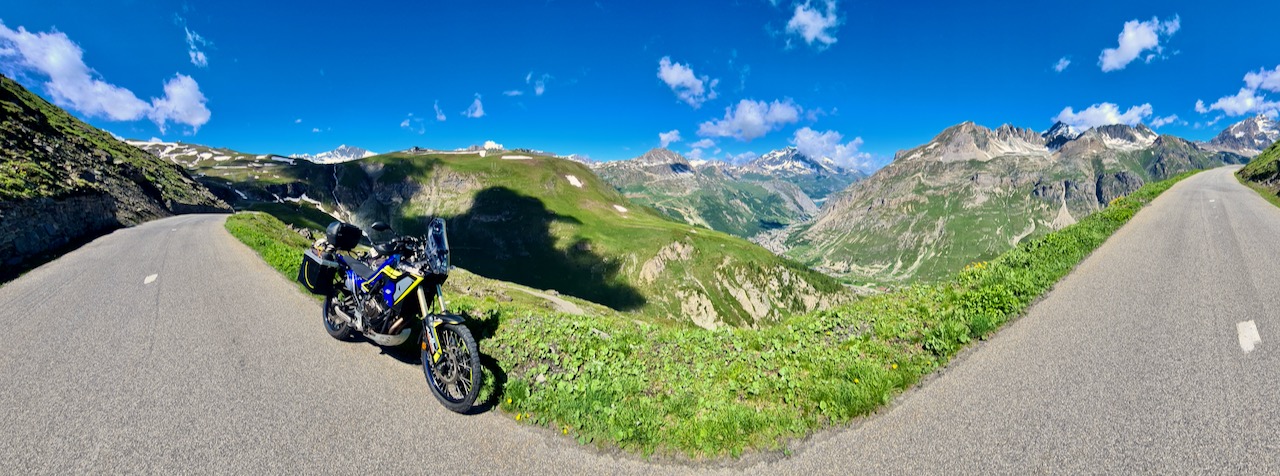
[229,173,1190,457]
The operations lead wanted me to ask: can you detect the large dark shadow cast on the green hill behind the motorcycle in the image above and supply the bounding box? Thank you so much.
[449,187,645,311]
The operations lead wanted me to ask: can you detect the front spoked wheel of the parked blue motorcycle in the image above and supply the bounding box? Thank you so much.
[422,322,484,413]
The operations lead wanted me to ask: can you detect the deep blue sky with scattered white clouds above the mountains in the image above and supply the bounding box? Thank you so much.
[0,0,1280,166]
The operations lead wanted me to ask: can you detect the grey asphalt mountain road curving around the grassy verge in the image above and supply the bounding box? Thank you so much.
[0,169,1280,475]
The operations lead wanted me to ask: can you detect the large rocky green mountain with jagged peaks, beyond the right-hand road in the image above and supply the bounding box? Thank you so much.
[773,123,1248,283]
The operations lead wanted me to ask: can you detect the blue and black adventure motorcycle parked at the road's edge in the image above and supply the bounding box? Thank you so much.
[298,219,483,413]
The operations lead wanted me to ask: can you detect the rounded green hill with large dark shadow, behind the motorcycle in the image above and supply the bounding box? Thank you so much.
[340,154,844,325]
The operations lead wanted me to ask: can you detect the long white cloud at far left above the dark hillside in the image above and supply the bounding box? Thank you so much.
[0,23,210,133]
